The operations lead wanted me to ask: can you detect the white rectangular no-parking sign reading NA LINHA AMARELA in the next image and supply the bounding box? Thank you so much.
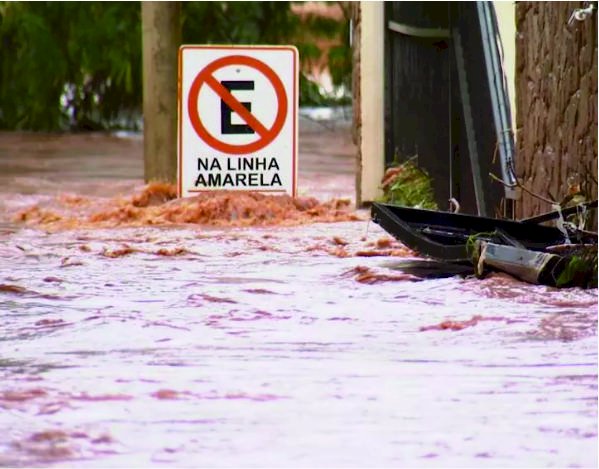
[178,46,299,197]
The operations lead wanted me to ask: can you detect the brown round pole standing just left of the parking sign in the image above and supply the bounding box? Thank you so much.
[141,2,181,183]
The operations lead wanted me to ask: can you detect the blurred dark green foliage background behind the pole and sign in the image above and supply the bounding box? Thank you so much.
[0,2,351,131]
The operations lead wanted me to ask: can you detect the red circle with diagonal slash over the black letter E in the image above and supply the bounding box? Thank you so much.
[187,55,287,155]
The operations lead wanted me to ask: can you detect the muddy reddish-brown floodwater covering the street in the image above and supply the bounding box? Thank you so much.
[0,126,598,467]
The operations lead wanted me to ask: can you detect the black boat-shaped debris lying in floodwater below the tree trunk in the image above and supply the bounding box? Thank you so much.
[371,200,597,286]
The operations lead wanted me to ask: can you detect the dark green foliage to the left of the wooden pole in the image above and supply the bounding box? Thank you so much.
[0,2,141,130]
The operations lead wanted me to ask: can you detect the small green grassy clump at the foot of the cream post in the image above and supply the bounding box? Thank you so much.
[382,157,438,210]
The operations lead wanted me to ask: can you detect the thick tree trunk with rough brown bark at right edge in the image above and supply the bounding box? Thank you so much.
[516,2,597,217]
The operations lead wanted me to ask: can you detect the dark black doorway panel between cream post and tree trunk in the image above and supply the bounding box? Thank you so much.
[385,2,504,216]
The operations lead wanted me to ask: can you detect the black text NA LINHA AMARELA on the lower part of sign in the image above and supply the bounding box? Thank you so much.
[195,157,283,188]
